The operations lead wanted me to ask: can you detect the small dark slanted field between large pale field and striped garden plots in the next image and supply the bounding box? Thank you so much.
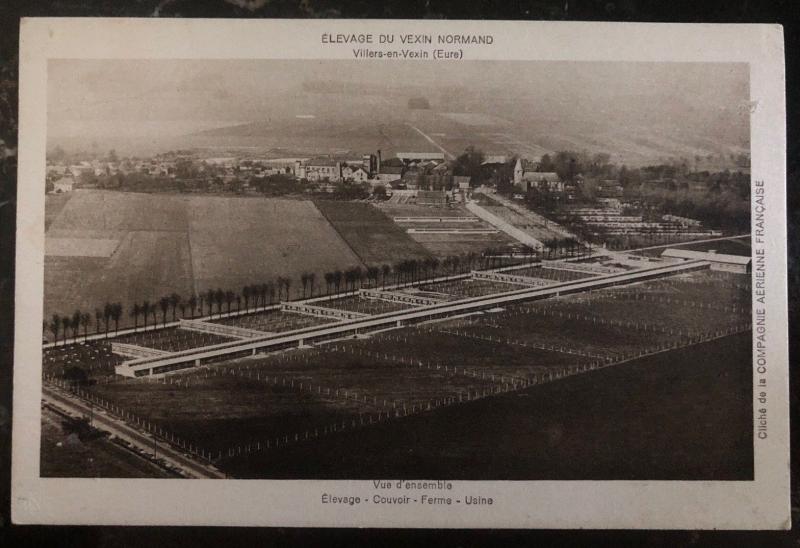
[315,200,430,265]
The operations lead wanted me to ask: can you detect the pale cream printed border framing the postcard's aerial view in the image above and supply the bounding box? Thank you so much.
[12,19,790,529]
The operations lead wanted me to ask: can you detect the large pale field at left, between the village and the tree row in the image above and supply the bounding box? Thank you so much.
[44,190,378,340]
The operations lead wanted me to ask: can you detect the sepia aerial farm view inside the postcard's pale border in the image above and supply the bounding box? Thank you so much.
[37,59,752,482]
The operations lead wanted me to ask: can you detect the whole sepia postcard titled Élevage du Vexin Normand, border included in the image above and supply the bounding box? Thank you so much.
[12,19,789,529]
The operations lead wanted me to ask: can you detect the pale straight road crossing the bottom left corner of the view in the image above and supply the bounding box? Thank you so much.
[42,385,225,479]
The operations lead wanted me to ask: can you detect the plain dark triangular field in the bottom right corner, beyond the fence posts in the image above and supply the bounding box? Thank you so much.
[224,333,753,480]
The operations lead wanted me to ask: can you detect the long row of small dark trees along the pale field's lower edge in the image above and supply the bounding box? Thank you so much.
[43,248,533,344]
